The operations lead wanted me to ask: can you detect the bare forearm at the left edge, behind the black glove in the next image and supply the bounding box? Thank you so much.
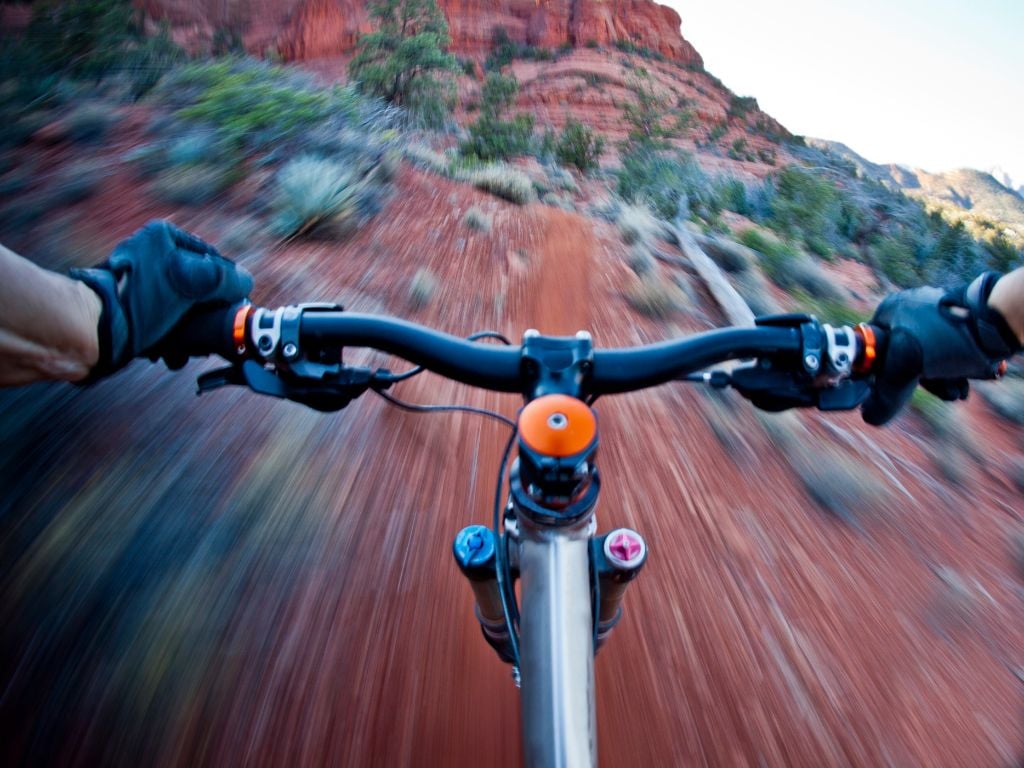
[0,246,102,386]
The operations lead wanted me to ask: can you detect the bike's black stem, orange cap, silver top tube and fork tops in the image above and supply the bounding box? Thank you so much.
[455,331,643,768]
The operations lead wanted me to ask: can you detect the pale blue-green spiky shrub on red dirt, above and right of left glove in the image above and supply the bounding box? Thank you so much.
[273,156,358,238]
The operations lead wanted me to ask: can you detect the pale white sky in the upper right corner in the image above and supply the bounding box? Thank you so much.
[660,0,1024,185]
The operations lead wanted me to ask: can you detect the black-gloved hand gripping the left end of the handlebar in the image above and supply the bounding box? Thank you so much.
[71,221,253,381]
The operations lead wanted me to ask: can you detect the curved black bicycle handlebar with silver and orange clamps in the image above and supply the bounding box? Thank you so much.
[165,304,883,408]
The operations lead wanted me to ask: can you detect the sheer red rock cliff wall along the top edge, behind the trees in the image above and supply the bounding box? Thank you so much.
[138,0,702,66]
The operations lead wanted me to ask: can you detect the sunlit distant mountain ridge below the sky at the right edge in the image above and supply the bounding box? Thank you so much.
[807,138,1024,240]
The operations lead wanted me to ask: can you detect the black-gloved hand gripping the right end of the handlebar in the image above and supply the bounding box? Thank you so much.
[862,272,1021,425]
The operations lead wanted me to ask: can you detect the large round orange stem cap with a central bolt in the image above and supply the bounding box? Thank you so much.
[519,394,597,458]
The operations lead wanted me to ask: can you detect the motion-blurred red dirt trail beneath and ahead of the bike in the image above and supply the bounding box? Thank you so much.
[0,157,1024,768]
